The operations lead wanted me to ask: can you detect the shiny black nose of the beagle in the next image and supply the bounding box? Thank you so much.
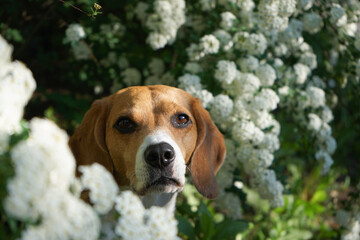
[144,142,175,168]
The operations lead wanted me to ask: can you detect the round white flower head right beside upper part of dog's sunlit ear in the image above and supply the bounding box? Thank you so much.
[210,94,234,124]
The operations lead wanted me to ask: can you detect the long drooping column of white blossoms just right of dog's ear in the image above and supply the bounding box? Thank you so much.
[210,56,283,207]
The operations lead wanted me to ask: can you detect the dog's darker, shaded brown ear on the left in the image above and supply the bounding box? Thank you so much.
[69,97,113,172]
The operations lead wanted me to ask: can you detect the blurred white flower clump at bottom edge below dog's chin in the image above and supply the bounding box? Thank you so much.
[115,191,179,240]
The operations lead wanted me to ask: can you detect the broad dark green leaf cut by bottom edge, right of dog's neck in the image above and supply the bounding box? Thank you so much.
[212,219,249,240]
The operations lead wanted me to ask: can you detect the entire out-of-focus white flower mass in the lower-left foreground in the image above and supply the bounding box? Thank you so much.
[0,36,178,240]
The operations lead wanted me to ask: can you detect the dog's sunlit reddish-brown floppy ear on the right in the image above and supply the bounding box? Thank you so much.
[190,98,225,199]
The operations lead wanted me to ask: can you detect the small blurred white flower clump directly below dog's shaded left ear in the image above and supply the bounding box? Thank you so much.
[79,163,119,214]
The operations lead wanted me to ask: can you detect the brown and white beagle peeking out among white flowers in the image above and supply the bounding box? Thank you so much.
[69,85,225,210]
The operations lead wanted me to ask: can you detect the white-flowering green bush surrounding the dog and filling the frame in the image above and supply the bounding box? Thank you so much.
[0,0,360,239]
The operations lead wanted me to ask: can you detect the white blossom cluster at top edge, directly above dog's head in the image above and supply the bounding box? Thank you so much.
[145,0,185,50]
